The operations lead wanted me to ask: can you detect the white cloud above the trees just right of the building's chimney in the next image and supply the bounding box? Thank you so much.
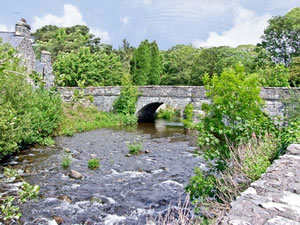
[32,4,110,42]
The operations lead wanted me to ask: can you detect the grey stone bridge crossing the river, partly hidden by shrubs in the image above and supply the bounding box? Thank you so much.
[59,86,300,122]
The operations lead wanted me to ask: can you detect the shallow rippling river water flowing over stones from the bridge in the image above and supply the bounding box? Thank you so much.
[0,120,205,225]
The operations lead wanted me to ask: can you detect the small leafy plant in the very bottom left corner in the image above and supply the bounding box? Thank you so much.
[0,196,22,221]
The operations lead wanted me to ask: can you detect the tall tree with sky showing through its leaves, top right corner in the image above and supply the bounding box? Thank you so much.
[262,8,300,67]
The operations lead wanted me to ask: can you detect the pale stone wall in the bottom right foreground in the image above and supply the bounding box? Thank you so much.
[221,144,300,225]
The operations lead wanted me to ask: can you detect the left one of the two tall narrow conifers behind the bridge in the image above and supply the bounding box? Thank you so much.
[131,40,151,85]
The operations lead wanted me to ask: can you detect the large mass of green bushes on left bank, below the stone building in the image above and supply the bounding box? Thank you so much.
[0,39,62,159]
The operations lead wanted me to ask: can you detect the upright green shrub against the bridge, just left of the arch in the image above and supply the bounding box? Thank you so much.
[113,75,138,115]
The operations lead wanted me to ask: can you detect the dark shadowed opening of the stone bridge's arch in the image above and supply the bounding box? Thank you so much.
[137,102,164,123]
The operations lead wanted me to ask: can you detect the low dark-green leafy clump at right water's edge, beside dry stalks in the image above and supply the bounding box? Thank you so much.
[185,168,216,201]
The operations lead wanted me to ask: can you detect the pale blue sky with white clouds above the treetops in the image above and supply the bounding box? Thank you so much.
[0,0,300,49]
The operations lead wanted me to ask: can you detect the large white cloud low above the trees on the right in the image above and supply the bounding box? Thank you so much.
[193,6,271,47]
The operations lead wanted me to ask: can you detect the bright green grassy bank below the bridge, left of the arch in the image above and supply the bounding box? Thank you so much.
[56,104,137,136]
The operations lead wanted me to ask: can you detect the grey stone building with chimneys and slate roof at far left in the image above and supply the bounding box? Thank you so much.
[0,19,54,87]
